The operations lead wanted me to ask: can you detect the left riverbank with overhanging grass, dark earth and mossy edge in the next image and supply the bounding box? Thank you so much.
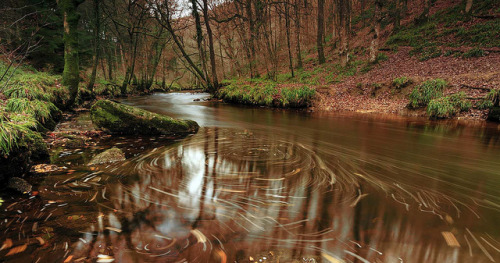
[0,61,178,185]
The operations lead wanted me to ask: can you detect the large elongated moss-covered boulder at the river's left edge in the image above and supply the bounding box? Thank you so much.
[90,100,199,135]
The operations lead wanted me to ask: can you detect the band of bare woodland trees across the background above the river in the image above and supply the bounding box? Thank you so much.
[0,0,482,105]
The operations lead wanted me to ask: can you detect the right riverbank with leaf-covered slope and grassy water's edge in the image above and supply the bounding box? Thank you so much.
[219,47,500,120]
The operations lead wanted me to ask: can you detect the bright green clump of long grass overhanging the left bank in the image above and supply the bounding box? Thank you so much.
[0,63,65,156]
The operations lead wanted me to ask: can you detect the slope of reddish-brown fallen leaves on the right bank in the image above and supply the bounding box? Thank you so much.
[313,47,500,119]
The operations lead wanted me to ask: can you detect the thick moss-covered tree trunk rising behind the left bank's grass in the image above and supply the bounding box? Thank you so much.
[58,0,84,106]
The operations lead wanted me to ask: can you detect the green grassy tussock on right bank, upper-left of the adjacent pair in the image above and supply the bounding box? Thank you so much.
[409,79,448,108]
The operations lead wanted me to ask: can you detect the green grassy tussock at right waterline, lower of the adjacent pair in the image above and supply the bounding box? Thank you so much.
[427,92,472,118]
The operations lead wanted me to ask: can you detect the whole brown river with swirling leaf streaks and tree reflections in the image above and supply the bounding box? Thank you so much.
[0,93,500,263]
